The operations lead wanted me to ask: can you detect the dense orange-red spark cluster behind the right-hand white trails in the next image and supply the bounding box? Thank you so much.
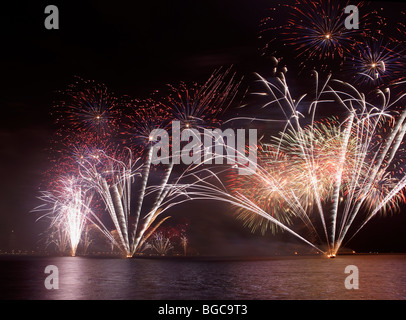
[228,118,356,233]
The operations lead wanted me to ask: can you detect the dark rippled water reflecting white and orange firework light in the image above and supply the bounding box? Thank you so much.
[0,255,406,300]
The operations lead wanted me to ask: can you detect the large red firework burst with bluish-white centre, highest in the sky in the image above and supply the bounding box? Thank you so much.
[261,0,382,71]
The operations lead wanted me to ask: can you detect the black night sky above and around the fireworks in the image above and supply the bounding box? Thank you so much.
[0,0,406,255]
